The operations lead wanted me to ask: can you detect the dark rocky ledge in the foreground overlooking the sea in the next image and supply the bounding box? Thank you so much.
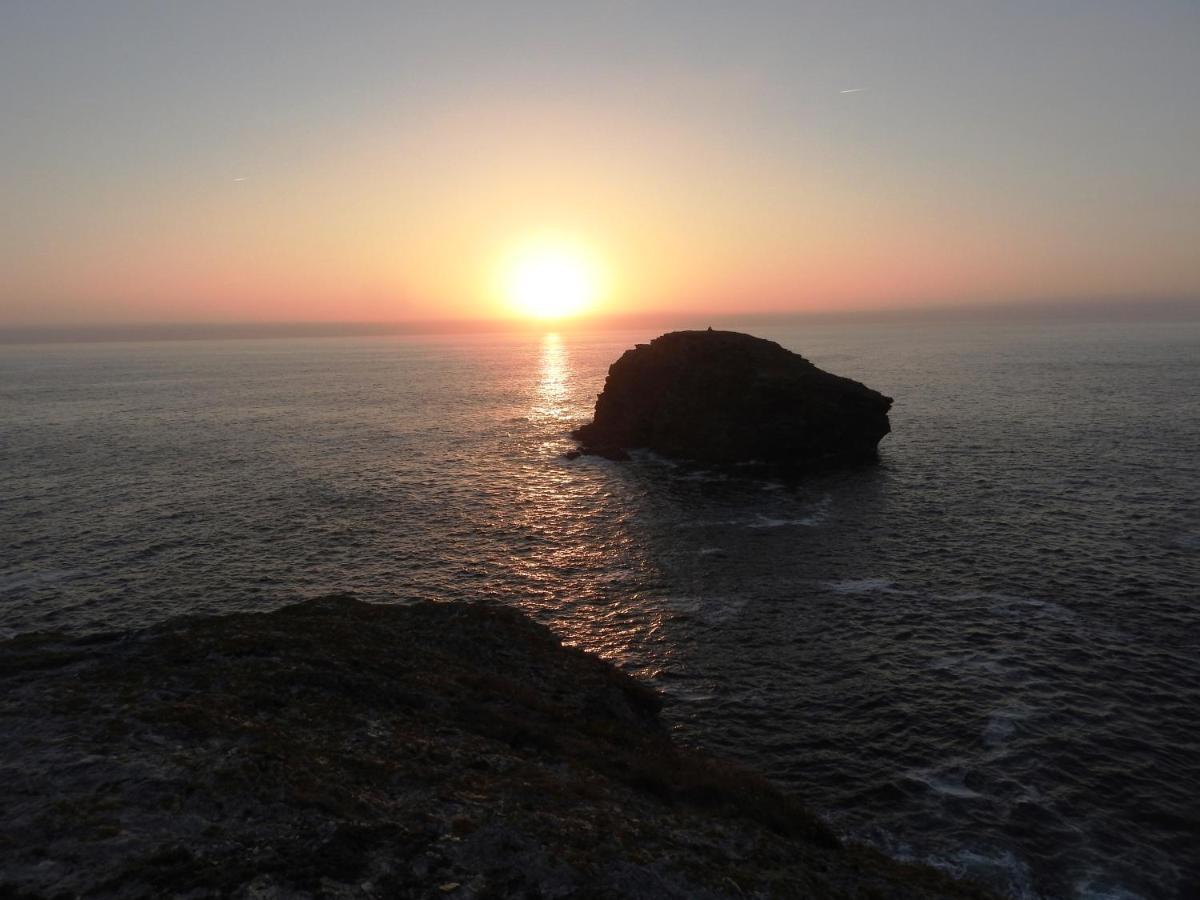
[0,596,983,899]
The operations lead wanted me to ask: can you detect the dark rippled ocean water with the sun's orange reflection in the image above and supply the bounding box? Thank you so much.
[0,324,1200,898]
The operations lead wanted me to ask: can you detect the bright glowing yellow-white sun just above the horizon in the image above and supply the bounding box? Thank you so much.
[503,240,601,319]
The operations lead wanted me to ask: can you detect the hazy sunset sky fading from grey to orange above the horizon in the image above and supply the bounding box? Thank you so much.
[0,0,1200,325]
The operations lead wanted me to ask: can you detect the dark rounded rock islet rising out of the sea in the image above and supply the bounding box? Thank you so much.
[575,330,892,466]
